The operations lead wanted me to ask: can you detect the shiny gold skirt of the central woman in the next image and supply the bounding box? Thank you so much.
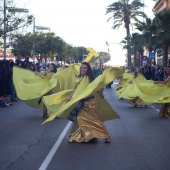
[69,99,110,142]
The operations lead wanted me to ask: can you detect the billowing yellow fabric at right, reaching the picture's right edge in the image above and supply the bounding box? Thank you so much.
[118,74,170,104]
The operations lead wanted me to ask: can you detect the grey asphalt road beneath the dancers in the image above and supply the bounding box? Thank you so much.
[0,80,170,170]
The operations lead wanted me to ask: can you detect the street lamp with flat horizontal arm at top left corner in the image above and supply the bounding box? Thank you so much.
[3,0,28,60]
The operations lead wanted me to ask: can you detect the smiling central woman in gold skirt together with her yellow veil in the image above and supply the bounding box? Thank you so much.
[43,62,123,143]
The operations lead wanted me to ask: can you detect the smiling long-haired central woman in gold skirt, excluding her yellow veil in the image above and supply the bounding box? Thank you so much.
[67,62,111,143]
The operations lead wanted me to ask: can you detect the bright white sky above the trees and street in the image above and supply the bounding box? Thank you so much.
[17,0,155,65]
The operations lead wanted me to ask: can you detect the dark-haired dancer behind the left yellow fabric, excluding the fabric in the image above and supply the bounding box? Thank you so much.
[34,63,57,118]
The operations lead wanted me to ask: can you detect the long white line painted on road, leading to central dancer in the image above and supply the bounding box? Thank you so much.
[39,121,72,170]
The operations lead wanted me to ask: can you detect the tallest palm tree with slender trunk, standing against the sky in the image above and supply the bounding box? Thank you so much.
[106,0,146,66]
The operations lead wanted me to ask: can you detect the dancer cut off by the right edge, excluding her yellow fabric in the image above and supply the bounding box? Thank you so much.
[155,66,170,118]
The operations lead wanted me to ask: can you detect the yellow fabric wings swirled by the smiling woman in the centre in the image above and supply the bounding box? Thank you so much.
[43,68,123,124]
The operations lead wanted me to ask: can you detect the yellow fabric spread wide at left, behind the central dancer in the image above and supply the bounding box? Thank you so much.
[13,64,80,108]
